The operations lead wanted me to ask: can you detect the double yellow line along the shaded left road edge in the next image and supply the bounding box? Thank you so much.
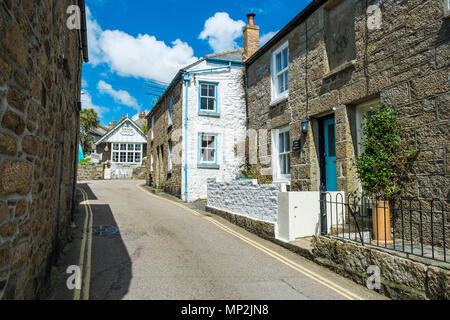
[73,188,93,300]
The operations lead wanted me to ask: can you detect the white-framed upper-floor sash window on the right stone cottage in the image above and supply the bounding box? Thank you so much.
[272,43,289,101]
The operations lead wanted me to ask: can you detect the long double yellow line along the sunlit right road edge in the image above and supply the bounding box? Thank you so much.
[137,185,364,300]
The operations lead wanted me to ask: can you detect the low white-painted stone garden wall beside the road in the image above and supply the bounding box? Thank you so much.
[208,179,283,223]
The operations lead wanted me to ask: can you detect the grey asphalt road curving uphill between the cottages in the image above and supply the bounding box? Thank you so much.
[52,181,385,300]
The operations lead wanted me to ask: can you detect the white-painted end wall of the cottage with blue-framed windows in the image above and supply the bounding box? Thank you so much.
[181,61,246,201]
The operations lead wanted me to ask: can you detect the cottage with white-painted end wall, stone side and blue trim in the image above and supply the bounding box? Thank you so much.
[148,49,246,201]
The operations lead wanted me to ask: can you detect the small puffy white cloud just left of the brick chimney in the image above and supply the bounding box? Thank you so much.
[199,12,245,53]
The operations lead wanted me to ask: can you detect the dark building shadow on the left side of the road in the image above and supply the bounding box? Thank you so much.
[53,183,132,300]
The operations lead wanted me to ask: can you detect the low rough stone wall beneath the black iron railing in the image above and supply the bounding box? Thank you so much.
[313,236,450,300]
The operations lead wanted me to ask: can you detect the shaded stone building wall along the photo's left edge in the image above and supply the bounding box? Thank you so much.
[0,0,88,299]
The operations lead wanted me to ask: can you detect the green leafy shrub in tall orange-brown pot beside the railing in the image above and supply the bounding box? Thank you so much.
[355,105,419,243]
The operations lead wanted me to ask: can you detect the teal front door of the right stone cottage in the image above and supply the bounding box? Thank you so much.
[323,118,337,191]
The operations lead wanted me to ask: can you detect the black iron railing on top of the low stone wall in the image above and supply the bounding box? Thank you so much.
[321,192,450,262]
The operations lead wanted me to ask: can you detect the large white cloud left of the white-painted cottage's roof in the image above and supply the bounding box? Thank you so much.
[86,8,198,82]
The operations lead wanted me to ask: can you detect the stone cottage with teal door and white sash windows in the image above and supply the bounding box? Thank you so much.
[245,0,450,199]
